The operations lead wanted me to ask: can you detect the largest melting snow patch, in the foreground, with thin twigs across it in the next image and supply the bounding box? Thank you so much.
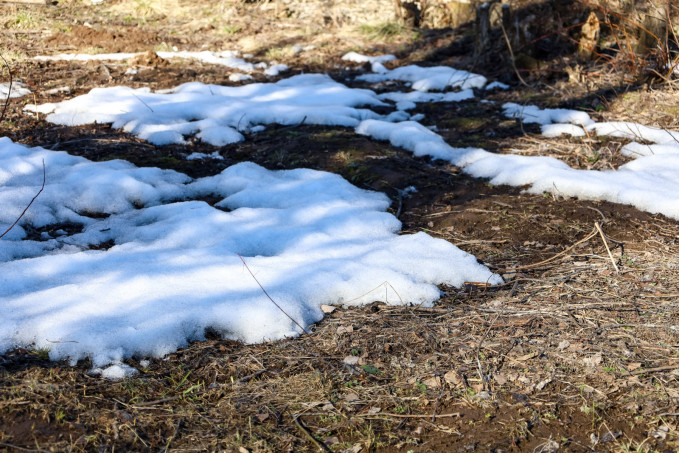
[0,138,501,368]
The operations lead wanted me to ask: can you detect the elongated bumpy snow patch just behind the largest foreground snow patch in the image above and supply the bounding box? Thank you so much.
[27,74,388,146]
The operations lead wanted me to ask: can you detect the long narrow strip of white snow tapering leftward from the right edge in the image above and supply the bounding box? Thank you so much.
[356,116,679,219]
